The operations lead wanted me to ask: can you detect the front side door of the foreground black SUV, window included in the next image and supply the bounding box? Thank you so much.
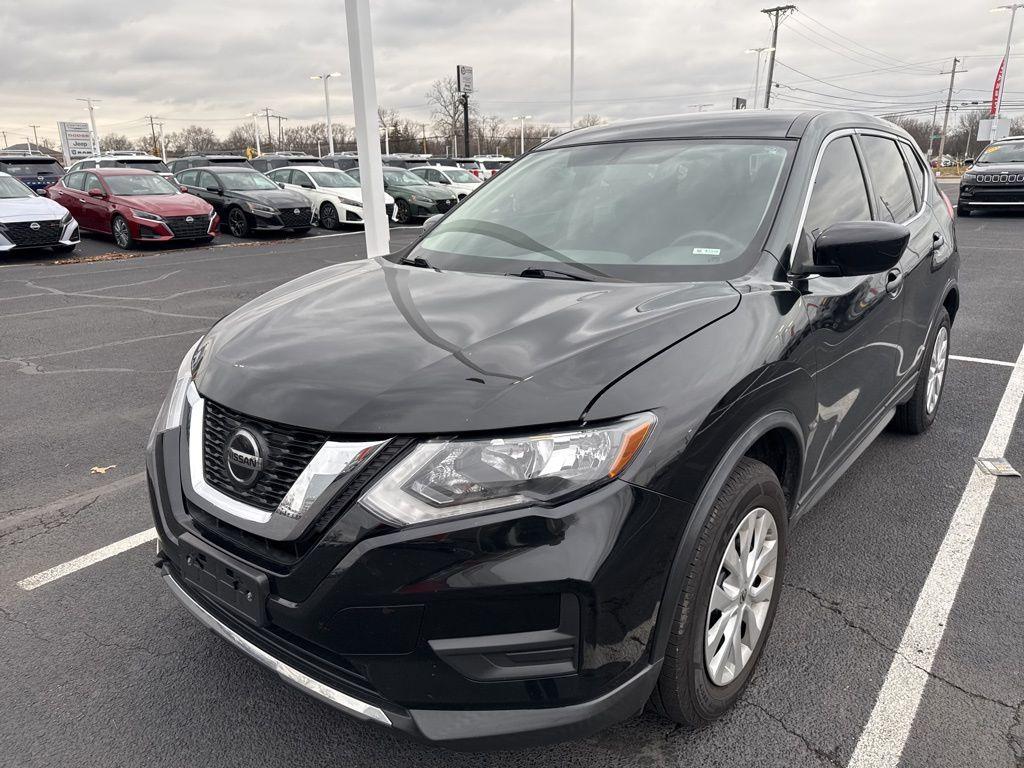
[797,132,902,481]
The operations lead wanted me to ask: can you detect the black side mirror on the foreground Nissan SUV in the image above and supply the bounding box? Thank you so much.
[812,221,910,278]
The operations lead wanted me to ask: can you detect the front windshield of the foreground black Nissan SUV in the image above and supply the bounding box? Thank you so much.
[406,139,790,282]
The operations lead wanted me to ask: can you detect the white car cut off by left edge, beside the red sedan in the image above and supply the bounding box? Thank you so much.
[0,171,80,253]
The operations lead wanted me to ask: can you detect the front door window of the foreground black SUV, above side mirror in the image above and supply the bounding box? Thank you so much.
[804,136,868,239]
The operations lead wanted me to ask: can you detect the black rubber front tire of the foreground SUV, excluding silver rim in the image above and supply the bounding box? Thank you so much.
[650,458,787,728]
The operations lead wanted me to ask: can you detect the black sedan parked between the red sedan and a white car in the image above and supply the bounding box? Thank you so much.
[176,165,312,238]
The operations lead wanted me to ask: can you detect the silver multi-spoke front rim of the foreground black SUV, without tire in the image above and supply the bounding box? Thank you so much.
[705,507,778,686]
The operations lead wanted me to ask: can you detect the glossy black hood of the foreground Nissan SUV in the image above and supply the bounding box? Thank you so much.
[196,259,739,435]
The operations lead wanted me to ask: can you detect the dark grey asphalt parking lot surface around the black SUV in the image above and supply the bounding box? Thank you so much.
[0,185,1024,768]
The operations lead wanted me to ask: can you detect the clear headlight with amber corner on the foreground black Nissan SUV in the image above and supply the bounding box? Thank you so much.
[361,413,655,525]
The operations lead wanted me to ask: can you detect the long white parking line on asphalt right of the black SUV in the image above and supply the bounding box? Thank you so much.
[849,337,1024,768]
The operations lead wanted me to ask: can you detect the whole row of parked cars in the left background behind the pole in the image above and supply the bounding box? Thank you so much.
[0,153,502,257]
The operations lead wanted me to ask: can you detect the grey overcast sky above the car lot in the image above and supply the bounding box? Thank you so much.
[0,0,1024,143]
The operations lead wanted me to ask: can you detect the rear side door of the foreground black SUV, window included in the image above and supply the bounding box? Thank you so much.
[859,135,952,393]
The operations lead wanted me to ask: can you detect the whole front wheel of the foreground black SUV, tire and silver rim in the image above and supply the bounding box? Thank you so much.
[650,458,787,728]
